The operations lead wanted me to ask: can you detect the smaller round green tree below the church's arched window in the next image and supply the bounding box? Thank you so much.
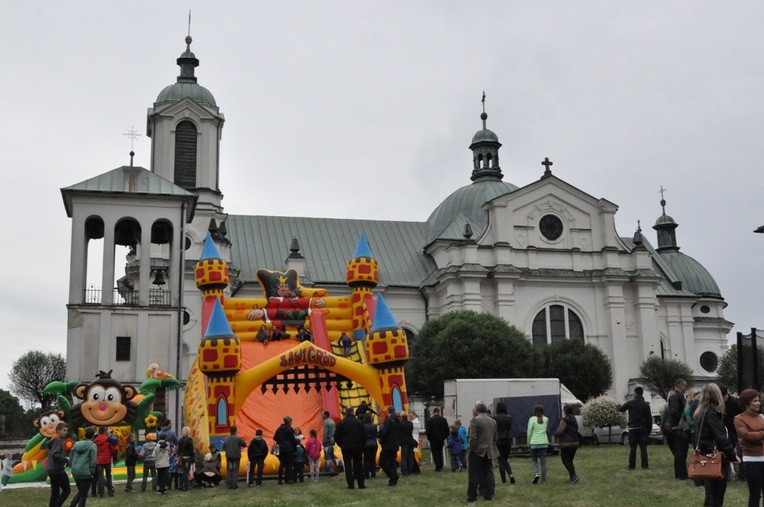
[541,339,613,401]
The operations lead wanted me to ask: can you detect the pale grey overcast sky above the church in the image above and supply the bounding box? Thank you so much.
[0,0,764,396]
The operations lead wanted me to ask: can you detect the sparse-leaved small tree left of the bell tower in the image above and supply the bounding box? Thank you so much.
[10,350,66,409]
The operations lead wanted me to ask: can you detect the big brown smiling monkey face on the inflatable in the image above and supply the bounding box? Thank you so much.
[72,371,138,426]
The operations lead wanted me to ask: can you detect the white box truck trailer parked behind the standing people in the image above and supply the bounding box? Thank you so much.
[443,378,592,443]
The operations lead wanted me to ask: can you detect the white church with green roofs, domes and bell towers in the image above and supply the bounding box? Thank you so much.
[62,37,732,422]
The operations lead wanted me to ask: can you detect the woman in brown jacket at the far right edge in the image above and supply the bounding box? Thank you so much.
[735,389,764,507]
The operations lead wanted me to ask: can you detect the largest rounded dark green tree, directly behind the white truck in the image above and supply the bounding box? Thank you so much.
[405,310,537,398]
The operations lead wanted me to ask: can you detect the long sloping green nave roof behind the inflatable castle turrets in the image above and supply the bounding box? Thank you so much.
[226,215,435,287]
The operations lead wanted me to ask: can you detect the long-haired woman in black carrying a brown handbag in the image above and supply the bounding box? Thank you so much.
[690,383,738,507]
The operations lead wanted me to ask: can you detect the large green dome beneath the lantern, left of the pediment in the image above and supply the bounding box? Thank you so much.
[427,179,518,243]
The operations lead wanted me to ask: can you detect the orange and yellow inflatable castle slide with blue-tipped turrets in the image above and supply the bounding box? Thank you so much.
[183,234,409,473]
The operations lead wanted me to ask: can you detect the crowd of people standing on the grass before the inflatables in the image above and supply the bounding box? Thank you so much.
[35,379,764,507]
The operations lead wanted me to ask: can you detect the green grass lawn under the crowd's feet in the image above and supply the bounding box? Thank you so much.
[0,445,748,507]
